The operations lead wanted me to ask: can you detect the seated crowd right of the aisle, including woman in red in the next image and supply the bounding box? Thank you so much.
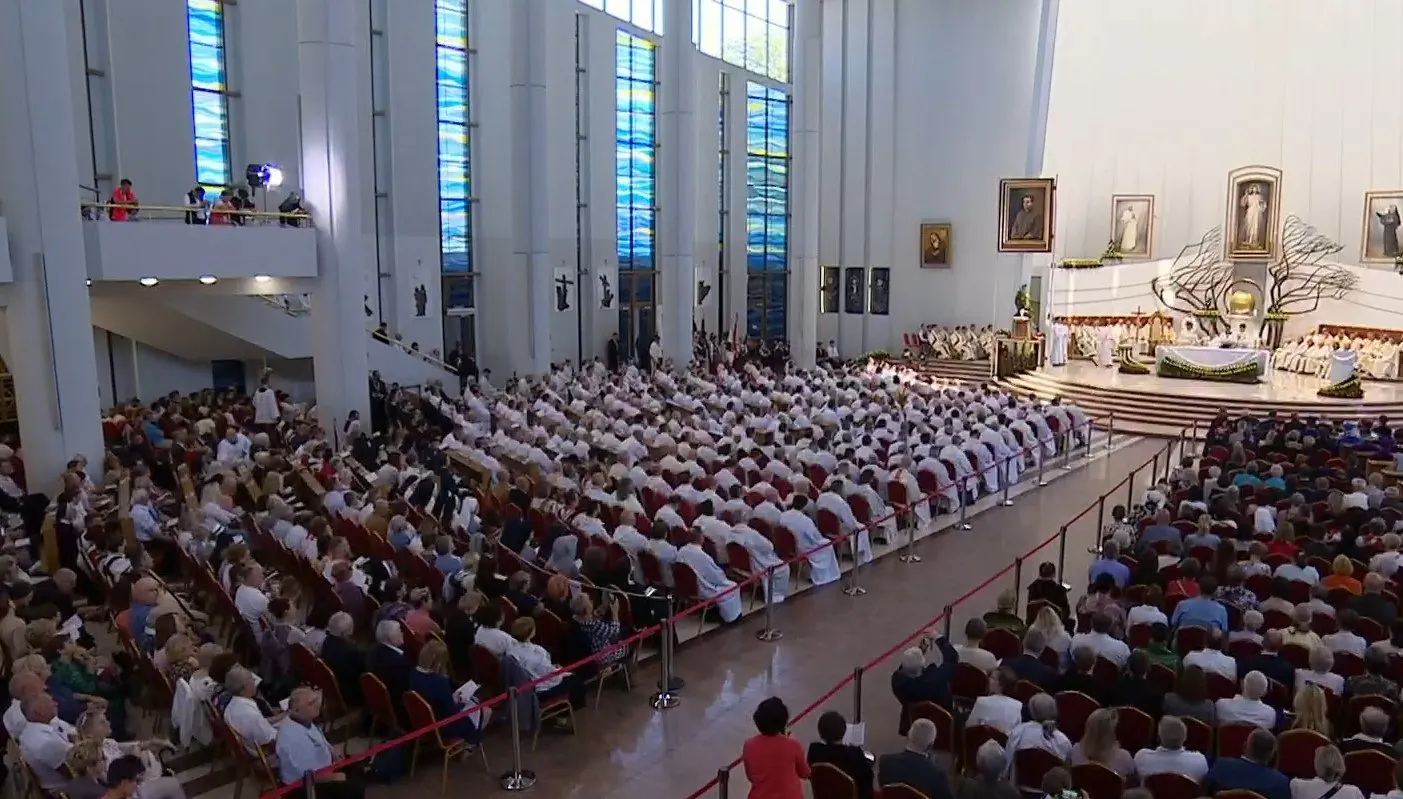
[746,417,1403,799]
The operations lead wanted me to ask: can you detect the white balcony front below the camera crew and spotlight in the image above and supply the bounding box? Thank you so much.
[83,205,317,281]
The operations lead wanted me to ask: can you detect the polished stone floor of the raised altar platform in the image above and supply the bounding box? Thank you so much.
[1038,359,1403,403]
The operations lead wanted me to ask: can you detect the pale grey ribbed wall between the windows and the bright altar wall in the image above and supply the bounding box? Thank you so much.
[815,0,1051,355]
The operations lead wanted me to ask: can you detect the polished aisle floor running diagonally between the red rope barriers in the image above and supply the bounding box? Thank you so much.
[206,441,1162,799]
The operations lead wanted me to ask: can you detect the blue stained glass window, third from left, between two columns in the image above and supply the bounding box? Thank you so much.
[615,29,658,271]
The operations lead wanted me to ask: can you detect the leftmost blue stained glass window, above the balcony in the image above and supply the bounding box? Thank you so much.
[185,0,233,188]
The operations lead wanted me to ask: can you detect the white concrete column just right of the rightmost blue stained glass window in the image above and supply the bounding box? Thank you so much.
[787,0,824,369]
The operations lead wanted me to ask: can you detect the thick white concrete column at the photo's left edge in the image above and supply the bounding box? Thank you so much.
[0,0,102,483]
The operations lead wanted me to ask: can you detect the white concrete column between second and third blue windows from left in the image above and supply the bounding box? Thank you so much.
[511,0,555,375]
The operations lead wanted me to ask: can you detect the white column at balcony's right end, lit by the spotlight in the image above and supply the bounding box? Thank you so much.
[297,0,373,435]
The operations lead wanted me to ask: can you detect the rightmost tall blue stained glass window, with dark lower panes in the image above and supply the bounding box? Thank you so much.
[745,81,790,338]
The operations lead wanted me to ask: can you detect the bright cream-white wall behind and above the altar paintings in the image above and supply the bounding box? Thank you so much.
[1043,0,1403,271]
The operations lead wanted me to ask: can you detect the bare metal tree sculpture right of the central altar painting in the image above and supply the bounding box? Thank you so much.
[1263,215,1360,348]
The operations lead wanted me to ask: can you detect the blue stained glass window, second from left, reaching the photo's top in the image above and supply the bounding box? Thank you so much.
[434,0,473,273]
